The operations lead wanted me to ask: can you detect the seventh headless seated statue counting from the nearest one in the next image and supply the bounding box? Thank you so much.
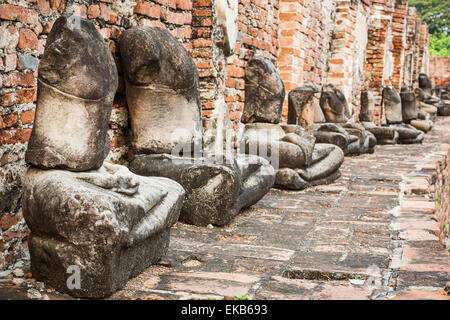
[382,86,424,144]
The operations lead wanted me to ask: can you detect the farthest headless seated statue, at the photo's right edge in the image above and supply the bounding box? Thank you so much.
[416,73,450,116]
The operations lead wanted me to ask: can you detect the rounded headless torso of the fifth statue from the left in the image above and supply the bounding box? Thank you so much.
[320,84,351,123]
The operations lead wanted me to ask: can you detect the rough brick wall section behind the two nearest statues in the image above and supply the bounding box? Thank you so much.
[0,0,196,270]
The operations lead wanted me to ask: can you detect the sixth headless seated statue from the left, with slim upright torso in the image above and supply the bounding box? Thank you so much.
[359,90,398,145]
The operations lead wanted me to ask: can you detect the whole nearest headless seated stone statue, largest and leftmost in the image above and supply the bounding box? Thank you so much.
[22,16,184,298]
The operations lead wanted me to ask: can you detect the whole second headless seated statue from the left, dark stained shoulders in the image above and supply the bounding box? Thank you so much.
[120,27,275,226]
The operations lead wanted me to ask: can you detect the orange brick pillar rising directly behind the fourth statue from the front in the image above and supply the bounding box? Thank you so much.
[277,0,335,121]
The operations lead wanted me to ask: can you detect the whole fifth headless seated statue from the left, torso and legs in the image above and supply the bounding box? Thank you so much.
[314,84,377,155]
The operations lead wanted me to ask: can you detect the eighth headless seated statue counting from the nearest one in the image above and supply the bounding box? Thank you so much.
[400,87,433,133]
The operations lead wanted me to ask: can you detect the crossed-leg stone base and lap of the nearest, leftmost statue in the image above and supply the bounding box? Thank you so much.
[22,163,184,298]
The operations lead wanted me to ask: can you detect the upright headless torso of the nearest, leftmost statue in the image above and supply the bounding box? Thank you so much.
[26,16,118,171]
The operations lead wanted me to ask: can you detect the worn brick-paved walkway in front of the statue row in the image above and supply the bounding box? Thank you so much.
[0,117,450,300]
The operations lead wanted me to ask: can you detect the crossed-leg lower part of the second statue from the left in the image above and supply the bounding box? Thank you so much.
[130,154,275,226]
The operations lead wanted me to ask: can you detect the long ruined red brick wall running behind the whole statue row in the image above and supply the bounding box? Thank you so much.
[0,0,428,270]
